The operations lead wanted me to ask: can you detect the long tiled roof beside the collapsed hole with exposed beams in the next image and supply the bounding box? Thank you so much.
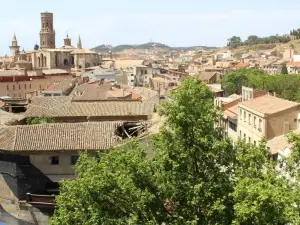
[0,121,146,152]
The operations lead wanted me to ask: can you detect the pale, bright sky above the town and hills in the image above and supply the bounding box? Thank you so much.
[0,0,300,55]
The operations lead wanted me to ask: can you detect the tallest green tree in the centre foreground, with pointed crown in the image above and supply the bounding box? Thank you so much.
[154,79,235,224]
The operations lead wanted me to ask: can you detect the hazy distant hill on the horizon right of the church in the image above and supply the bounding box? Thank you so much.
[92,42,216,53]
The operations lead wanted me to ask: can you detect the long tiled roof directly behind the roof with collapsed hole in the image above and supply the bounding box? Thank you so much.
[25,96,154,117]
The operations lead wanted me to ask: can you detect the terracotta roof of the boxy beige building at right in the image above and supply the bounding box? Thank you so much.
[239,95,299,114]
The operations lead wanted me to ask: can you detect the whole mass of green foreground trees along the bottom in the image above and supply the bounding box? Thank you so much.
[51,78,300,225]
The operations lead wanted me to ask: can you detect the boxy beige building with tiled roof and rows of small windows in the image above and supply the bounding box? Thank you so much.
[238,95,299,145]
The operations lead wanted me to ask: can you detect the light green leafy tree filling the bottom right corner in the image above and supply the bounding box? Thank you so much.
[232,143,299,225]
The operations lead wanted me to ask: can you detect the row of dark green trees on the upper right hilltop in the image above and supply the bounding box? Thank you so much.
[227,35,290,48]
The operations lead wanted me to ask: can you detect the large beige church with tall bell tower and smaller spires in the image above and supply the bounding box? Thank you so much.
[6,12,100,69]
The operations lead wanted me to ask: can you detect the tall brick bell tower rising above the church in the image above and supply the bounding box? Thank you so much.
[40,12,55,49]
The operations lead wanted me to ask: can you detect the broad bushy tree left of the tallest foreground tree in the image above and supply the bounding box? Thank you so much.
[50,142,168,225]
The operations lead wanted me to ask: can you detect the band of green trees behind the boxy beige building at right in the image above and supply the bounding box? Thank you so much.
[222,69,300,102]
